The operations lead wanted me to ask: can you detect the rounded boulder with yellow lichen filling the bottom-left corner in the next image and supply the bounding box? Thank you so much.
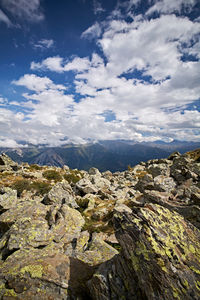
[0,246,70,300]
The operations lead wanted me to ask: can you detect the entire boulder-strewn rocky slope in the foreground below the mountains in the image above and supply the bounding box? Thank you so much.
[0,150,200,300]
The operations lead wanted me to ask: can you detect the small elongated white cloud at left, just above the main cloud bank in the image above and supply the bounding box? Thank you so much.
[12,74,66,92]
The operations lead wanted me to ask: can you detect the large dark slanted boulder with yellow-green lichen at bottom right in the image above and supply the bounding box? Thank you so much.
[89,204,200,300]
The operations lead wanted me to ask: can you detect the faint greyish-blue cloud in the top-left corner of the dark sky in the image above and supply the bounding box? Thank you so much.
[1,0,44,22]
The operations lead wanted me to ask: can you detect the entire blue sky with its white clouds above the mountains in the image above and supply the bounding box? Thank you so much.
[0,0,200,147]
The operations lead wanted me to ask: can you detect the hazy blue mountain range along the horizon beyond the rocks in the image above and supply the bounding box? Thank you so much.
[0,140,200,172]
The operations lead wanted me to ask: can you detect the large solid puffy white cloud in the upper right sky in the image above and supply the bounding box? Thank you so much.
[99,15,200,80]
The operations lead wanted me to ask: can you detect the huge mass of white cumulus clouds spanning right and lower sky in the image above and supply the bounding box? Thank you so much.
[0,0,200,145]
